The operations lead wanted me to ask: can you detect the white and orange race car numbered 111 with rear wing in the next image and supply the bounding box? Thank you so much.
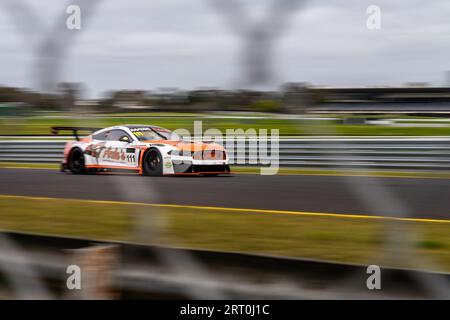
[51,125,230,176]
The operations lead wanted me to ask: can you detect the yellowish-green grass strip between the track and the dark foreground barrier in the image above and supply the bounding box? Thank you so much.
[0,197,450,272]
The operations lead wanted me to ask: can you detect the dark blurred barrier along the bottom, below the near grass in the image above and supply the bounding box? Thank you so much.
[0,232,450,299]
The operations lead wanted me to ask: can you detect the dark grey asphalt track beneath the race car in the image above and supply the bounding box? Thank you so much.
[0,169,450,219]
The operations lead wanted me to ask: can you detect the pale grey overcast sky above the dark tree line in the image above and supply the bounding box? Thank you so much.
[0,0,450,96]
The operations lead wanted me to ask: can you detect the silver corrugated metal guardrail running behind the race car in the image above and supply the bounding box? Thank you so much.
[0,137,450,169]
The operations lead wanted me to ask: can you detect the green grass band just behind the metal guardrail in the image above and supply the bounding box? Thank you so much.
[0,114,450,136]
